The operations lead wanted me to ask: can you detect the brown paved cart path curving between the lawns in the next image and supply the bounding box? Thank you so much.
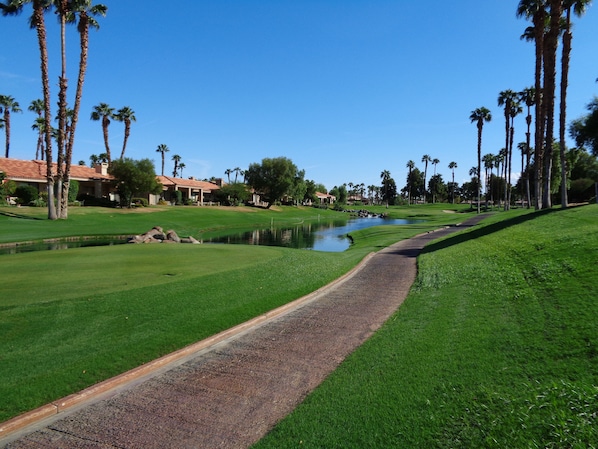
[0,216,483,449]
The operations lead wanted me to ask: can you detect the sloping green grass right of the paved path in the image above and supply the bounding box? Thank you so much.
[255,205,598,448]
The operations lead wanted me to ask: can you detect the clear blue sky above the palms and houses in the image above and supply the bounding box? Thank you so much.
[0,0,598,189]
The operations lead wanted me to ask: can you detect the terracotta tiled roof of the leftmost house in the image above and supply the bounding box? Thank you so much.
[0,158,112,182]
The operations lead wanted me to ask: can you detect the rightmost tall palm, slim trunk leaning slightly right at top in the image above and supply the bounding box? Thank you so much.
[559,0,592,208]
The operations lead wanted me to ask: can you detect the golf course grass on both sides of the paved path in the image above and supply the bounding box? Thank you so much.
[0,204,598,448]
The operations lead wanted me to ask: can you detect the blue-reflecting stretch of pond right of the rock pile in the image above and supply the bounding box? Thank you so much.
[203,217,421,252]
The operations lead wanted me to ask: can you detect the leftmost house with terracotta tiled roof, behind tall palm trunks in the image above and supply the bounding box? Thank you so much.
[0,158,114,200]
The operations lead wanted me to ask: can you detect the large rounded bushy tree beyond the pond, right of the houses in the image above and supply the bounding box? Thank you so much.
[245,157,303,208]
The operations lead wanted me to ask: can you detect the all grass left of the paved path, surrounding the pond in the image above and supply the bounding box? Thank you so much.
[0,203,478,421]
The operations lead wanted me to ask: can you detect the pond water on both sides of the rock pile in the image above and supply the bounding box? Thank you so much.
[0,217,421,255]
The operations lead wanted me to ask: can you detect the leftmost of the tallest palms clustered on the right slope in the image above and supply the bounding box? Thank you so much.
[517,0,546,209]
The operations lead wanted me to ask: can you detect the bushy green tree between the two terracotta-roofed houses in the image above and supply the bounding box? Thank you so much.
[109,158,162,207]
